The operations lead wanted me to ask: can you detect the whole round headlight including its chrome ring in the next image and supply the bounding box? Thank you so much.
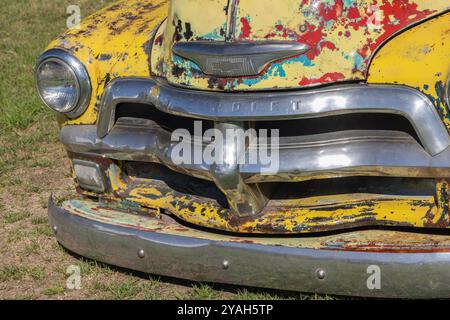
[36,49,91,118]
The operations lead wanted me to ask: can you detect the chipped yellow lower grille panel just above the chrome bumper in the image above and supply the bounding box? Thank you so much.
[71,161,450,234]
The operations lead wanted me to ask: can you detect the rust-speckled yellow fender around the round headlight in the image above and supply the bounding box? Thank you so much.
[48,0,168,126]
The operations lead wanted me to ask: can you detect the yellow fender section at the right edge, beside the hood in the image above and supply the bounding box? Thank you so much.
[368,13,450,128]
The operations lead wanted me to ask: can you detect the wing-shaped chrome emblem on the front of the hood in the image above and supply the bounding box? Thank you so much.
[172,41,310,77]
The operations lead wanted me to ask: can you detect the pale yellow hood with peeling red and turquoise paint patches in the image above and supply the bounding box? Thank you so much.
[151,0,450,91]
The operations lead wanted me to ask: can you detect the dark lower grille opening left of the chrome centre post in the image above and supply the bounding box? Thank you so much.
[124,162,229,209]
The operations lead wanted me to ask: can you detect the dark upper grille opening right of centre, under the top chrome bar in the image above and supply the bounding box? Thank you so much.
[254,113,420,143]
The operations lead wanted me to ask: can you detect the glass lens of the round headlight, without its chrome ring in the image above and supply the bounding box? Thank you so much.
[36,59,80,113]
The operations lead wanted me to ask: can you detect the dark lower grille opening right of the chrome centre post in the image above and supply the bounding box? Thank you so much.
[263,177,436,200]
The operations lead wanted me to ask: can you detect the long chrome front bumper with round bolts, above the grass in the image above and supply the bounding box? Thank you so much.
[49,199,450,298]
